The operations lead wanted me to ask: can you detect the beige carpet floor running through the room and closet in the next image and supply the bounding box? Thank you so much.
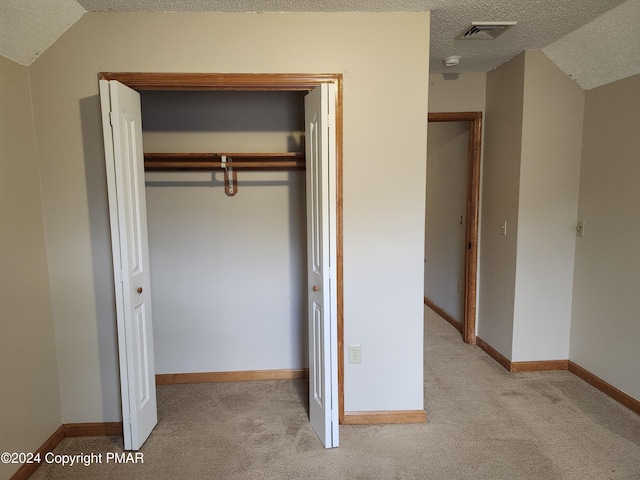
[31,309,640,480]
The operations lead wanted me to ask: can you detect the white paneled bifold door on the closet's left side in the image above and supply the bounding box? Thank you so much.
[100,80,158,450]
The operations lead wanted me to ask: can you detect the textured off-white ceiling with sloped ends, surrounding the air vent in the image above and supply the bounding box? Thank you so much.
[0,0,640,89]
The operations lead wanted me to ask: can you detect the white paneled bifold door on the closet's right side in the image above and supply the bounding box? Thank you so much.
[304,83,338,448]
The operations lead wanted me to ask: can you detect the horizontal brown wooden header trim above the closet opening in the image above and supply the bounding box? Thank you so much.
[98,72,342,91]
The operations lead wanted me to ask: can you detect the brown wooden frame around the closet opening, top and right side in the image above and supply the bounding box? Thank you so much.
[98,72,344,424]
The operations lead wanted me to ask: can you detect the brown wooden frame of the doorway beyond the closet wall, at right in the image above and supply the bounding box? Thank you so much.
[427,112,482,344]
